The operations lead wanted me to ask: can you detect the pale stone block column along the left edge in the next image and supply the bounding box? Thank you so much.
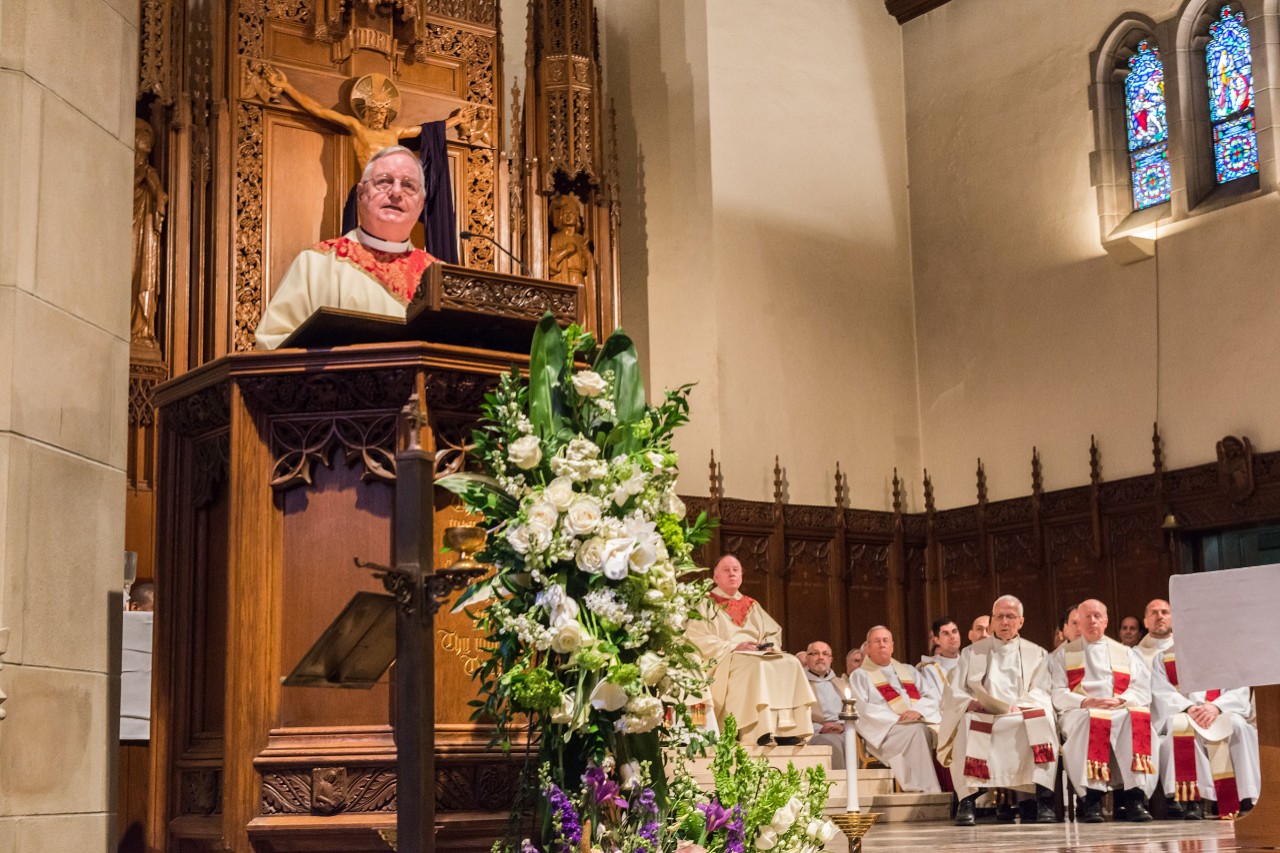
[0,0,138,853]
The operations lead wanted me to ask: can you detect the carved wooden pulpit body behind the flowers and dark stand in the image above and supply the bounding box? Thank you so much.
[148,342,527,853]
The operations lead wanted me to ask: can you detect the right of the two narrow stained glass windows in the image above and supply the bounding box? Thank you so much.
[1204,5,1258,183]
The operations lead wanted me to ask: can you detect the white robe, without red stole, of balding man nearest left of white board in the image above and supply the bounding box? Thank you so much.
[1048,637,1158,797]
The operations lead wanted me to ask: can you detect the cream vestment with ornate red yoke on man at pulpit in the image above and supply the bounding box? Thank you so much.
[253,229,435,350]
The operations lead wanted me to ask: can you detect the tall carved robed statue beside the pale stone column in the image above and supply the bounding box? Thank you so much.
[129,119,169,347]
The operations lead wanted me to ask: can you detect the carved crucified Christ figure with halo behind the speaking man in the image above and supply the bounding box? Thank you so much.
[261,64,462,173]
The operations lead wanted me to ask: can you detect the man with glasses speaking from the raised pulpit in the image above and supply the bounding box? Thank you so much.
[255,145,445,350]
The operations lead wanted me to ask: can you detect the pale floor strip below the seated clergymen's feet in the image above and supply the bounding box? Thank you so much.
[863,821,1280,853]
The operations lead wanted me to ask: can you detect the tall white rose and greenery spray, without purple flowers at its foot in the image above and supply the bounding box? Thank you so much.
[438,314,708,795]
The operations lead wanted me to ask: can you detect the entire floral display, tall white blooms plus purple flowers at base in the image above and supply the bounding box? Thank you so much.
[438,314,836,853]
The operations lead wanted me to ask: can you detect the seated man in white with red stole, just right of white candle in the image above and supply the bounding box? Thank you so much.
[849,625,942,794]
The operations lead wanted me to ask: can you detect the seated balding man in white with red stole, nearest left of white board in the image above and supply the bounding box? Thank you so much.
[1048,598,1156,824]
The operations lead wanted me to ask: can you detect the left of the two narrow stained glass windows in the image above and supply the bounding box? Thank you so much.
[1124,40,1172,210]
